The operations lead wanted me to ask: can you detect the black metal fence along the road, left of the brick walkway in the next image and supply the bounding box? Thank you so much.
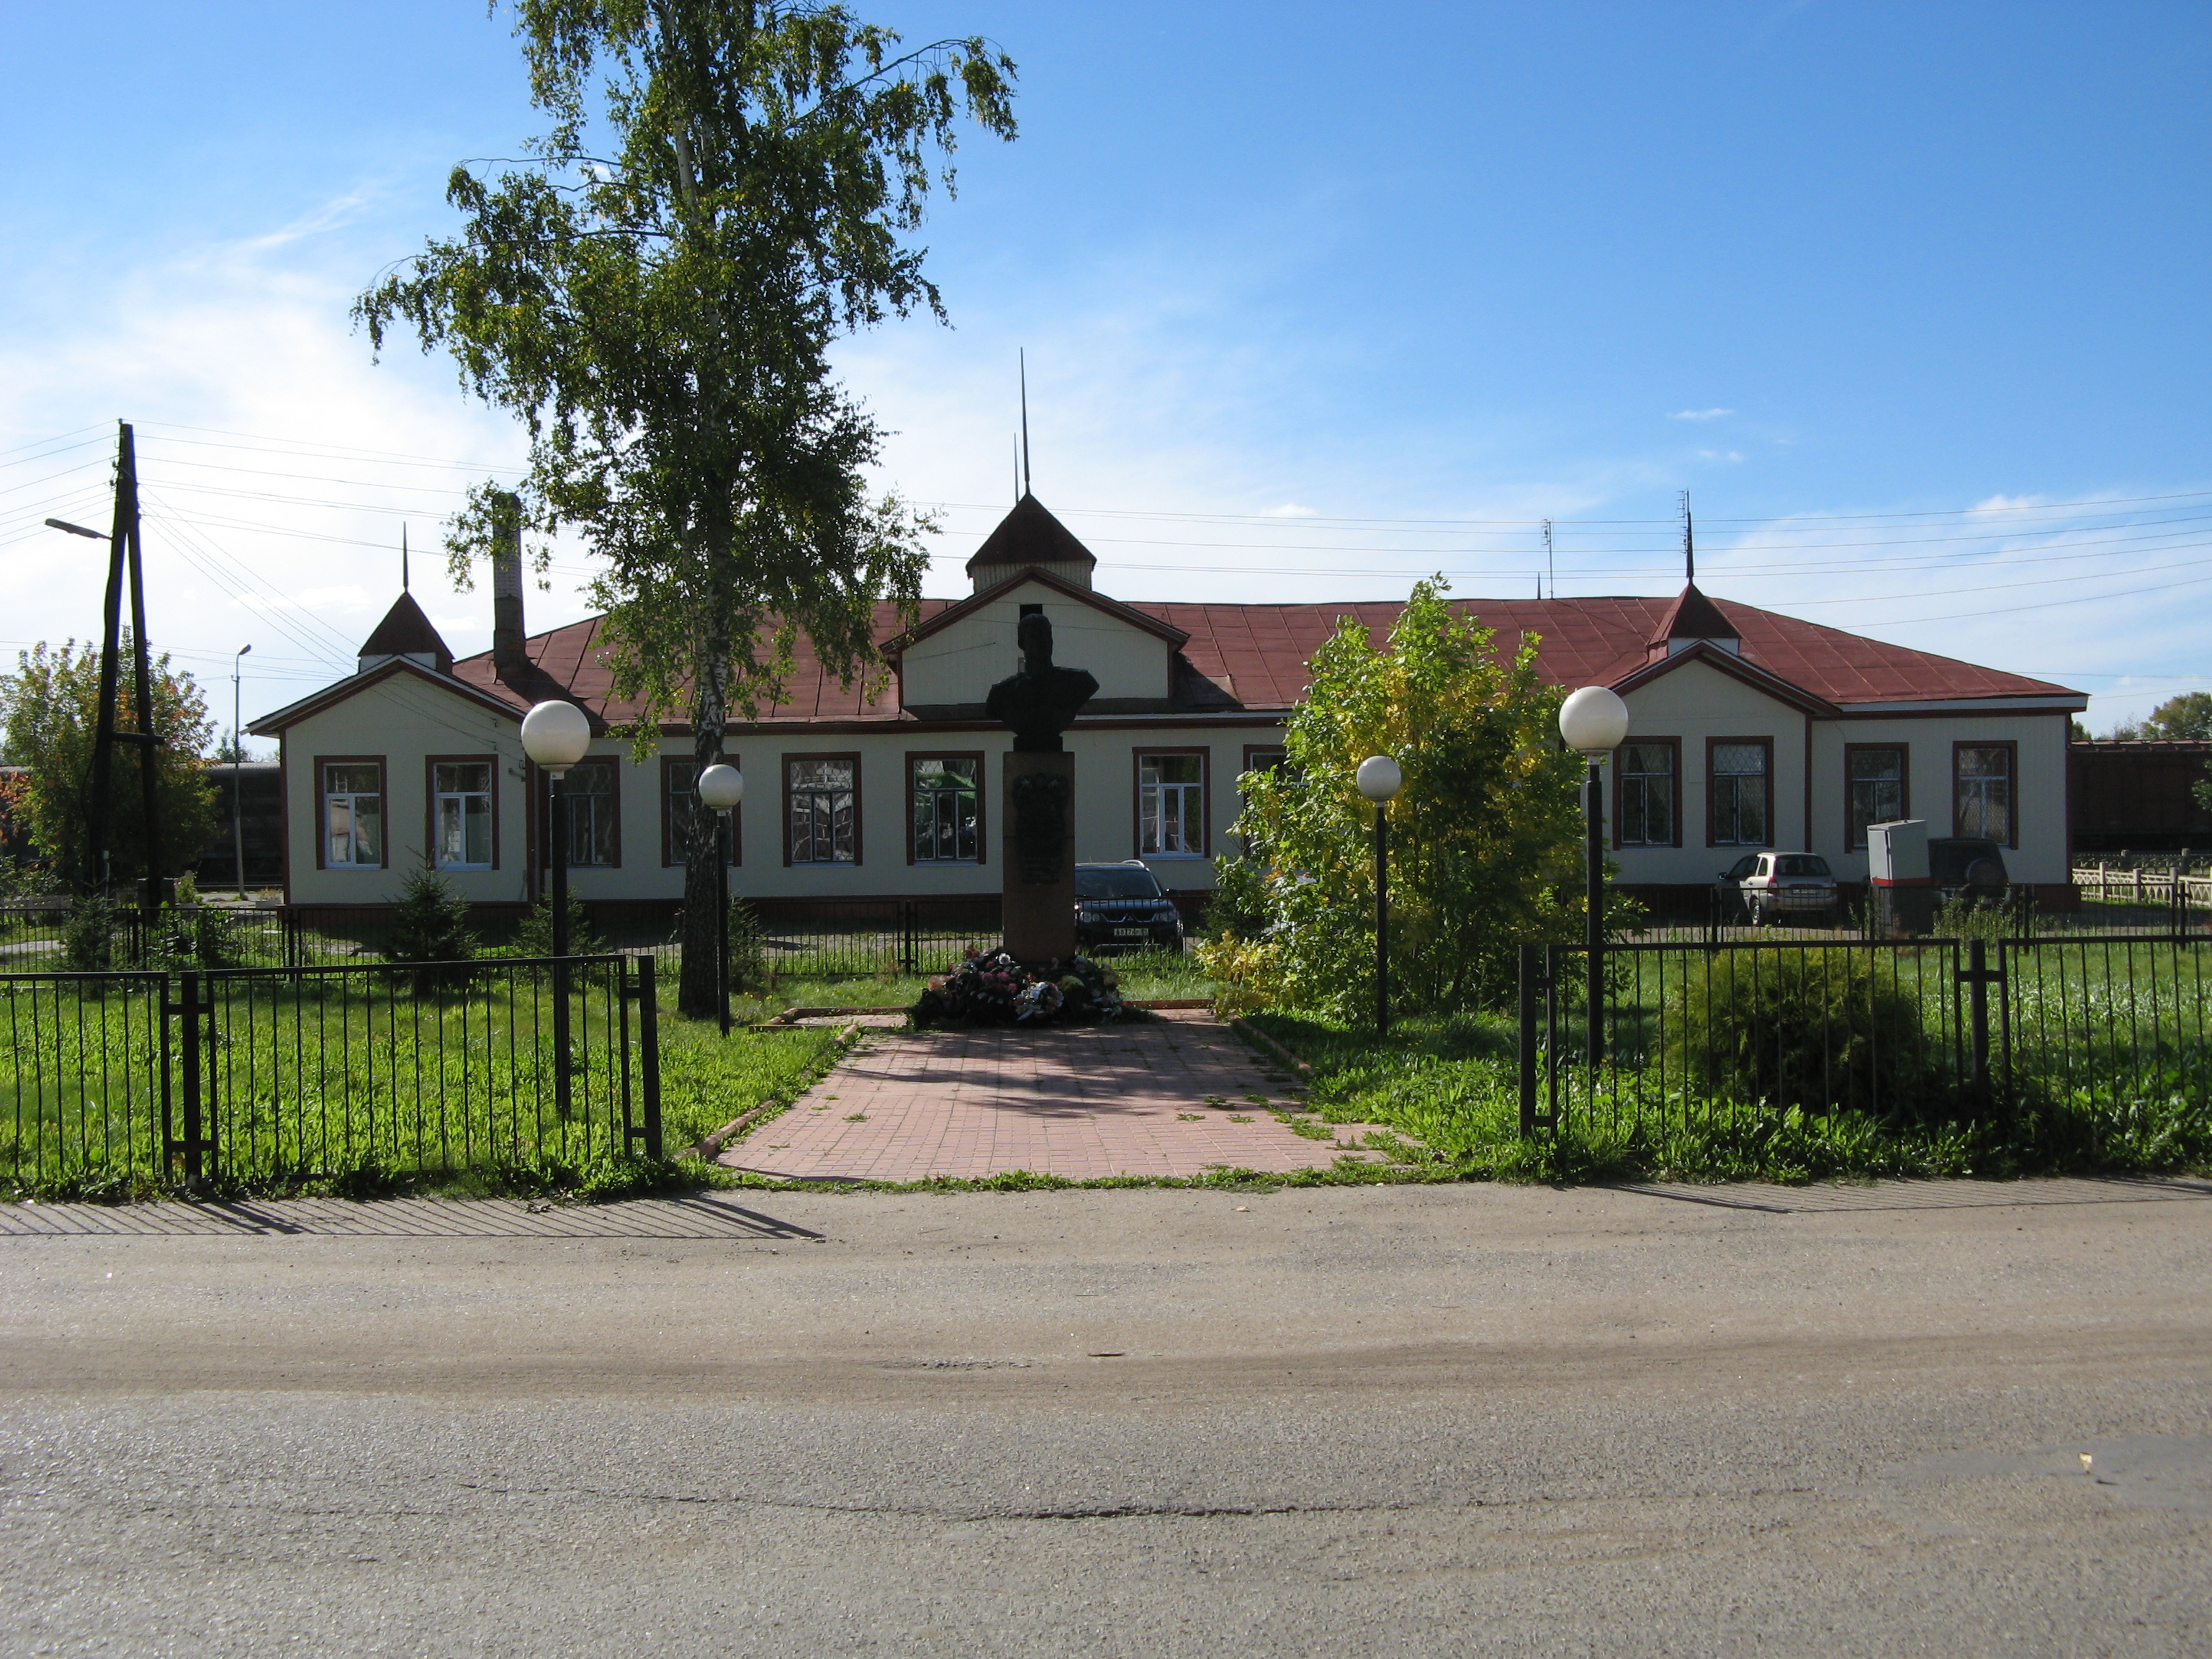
[0,956,662,1184]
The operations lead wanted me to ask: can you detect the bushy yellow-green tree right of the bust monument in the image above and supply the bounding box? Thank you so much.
[1201,582,1581,1020]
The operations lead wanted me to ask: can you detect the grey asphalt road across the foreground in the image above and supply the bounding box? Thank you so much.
[0,1188,2212,1659]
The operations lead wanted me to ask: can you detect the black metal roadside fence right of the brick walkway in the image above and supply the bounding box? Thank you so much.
[1519,931,2212,1135]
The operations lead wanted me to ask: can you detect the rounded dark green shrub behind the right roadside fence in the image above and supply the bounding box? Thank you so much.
[1661,949,1942,1112]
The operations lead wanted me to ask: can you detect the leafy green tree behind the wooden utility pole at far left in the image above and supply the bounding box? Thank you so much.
[0,631,215,889]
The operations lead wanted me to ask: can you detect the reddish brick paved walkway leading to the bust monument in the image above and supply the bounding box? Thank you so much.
[721,1013,1367,1181]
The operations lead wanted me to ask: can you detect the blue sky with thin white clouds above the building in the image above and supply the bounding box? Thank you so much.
[0,0,2212,728]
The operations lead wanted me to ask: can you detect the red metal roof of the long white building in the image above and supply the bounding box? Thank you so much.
[454,597,2080,724]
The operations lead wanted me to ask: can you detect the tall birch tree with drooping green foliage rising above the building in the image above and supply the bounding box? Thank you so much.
[356,0,1015,1013]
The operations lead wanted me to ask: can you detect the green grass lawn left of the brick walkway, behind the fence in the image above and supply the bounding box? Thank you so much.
[0,974,840,1197]
